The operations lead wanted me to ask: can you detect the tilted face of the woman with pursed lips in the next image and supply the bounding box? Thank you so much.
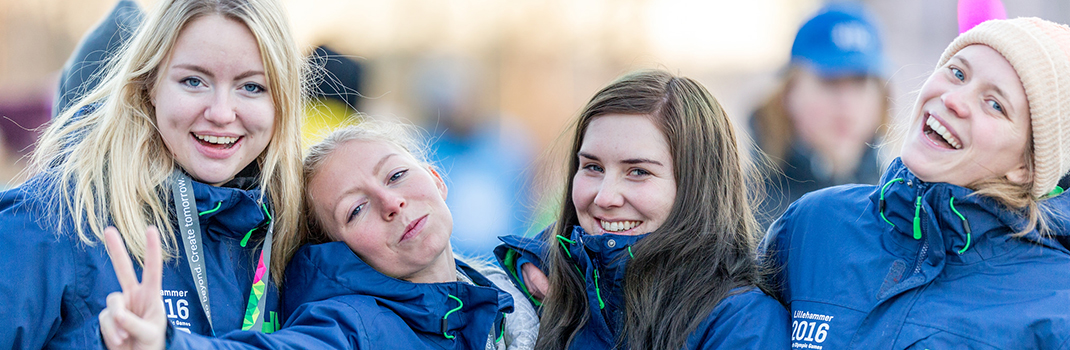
[307,140,456,283]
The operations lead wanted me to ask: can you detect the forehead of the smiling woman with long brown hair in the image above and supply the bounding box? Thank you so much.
[580,115,670,159]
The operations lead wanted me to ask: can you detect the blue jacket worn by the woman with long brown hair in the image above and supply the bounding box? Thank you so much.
[495,226,790,349]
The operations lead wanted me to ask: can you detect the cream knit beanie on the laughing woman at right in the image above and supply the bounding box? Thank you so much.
[936,18,1070,198]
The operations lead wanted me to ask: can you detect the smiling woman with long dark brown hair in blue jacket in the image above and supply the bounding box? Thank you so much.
[498,71,790,349]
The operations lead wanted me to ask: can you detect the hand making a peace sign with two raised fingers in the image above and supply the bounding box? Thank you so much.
[100,226,167,350]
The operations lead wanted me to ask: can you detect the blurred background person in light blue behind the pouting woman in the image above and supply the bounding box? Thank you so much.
[415,58,533,257]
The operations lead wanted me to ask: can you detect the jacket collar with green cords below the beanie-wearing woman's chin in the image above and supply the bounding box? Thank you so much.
[871,158,1070,263]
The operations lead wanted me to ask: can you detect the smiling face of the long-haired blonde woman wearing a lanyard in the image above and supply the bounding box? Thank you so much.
[151,15,275,185]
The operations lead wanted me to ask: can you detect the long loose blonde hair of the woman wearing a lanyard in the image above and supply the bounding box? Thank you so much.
[32,0,305,280]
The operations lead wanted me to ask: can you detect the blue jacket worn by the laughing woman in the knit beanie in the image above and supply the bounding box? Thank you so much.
[763,159,1070,349]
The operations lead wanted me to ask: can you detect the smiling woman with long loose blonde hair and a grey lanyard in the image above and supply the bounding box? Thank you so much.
[0,0,303,349]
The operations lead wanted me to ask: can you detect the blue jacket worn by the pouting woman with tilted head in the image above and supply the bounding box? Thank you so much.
[169,242,513,350]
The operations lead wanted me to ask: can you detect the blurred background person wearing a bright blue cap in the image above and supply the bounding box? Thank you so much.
[750,3,889,227]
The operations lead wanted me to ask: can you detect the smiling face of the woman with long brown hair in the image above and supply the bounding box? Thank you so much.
[572,115,676,234]
